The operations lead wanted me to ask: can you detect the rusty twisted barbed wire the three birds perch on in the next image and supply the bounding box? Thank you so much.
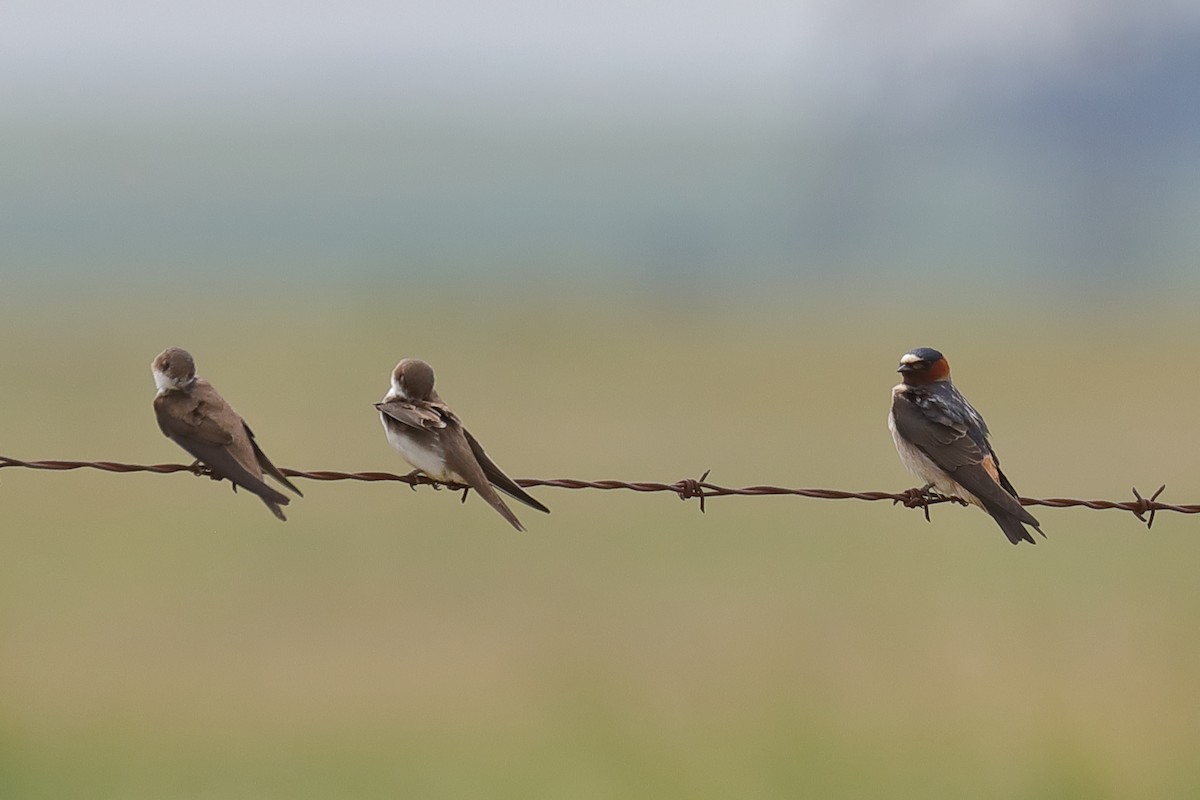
[0,456,1185,529]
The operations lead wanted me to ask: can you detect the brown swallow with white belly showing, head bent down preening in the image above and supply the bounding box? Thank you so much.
[374,359,550,530]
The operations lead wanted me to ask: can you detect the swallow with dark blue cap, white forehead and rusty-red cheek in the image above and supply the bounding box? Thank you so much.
[888,347,1045,545]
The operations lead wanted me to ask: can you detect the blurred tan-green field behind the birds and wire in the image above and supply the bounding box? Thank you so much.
[0,287,1200,800]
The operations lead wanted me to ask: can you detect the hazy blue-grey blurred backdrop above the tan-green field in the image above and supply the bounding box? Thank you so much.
[0,0,1200,283]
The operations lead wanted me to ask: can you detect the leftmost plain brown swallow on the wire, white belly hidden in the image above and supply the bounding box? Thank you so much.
[150,347,304,522]
